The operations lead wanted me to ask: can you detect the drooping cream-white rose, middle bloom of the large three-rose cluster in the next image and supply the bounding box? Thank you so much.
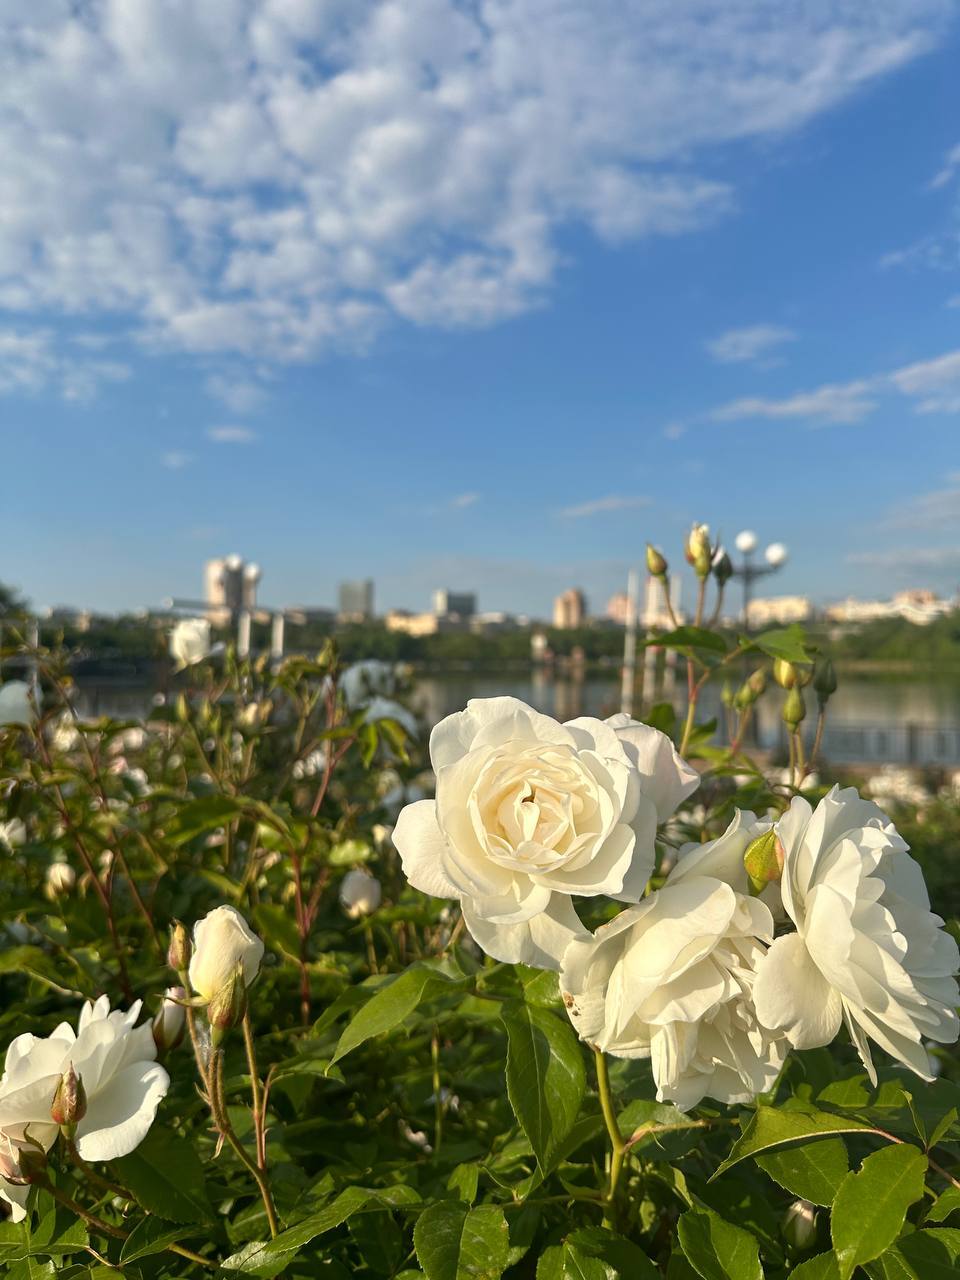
[559,874,787,1111]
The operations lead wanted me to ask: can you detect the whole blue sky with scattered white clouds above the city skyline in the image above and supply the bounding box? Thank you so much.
[0,0,960,613]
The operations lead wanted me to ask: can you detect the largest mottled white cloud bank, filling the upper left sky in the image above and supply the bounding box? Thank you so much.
[0,0,951,373]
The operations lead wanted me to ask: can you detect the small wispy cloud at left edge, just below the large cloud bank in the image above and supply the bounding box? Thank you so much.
[0,328,131,403]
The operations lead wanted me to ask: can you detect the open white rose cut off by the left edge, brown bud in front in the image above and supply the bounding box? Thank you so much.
[0,996,170,1221]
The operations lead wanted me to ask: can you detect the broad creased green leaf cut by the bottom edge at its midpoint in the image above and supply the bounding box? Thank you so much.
[413,1201,509,1280]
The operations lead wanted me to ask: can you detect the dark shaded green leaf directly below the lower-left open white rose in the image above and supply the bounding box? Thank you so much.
[114,1126,211,1222]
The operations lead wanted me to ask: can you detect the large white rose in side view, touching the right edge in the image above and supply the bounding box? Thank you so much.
[755,787,960,1083]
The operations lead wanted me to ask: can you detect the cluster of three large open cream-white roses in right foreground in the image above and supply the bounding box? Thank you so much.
[393,698,960,1110]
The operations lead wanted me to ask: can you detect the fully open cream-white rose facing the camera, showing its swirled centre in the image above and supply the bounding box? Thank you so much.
[393,698,699,969]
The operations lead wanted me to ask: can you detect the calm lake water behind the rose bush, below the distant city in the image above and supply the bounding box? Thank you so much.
[69,668,960,767]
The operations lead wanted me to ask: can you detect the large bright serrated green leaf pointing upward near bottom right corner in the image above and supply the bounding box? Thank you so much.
[831,1143,927,1280]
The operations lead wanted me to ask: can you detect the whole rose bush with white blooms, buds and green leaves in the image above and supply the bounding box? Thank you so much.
[0,540,960,1280]
